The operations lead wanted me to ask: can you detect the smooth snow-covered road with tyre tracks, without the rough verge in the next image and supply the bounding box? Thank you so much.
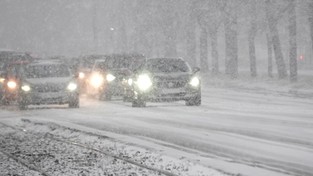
[0,84,313,176]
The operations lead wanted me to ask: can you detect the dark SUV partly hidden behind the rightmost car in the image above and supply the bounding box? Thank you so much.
[88,54,145,101]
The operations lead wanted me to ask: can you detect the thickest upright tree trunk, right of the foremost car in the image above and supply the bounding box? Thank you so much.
[224,9,238,78]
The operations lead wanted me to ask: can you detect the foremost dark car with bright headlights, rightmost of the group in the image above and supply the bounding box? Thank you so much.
[126,58,201,107]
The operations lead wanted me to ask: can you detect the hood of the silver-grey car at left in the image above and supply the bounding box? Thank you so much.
[24,77,73,85]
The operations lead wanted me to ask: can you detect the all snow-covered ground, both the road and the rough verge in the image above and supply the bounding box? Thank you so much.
[0,74,313,176]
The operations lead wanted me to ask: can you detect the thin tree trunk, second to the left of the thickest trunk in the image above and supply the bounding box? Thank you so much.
[200,28,209,72]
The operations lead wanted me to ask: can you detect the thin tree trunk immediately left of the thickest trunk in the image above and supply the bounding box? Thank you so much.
[210,30,219,75]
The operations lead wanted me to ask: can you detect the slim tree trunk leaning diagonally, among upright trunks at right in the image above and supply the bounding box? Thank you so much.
[266,0,287,79]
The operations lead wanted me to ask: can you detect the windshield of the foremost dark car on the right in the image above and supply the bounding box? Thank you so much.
[147,58,190,73]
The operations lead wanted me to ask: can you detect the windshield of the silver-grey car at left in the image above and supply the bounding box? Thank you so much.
[25,64,70,78]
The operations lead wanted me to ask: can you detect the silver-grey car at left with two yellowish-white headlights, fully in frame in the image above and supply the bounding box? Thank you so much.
[18,60,79,110]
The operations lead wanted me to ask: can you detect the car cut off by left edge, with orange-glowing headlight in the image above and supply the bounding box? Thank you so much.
[0,61,30,105]
